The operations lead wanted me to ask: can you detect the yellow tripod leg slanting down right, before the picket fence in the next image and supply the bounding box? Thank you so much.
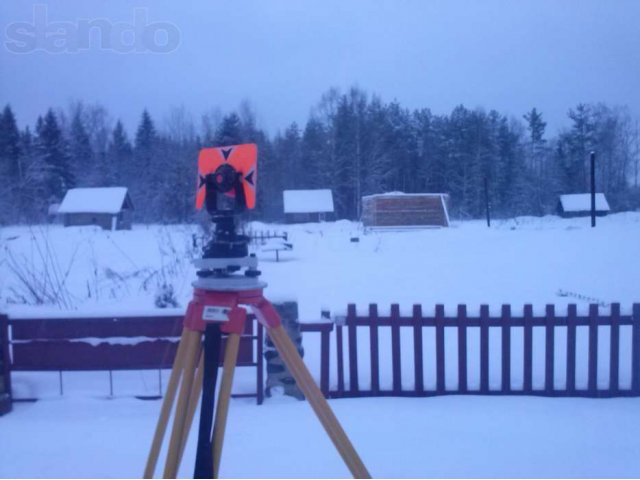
[267,325,371,478]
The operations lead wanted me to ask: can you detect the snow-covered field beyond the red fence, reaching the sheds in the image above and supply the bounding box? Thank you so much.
[0,212,640,321]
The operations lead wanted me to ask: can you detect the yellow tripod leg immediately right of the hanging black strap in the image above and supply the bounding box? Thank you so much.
[213,333,240,478]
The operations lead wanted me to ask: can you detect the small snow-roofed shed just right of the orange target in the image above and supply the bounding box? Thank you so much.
[282,189,335,223]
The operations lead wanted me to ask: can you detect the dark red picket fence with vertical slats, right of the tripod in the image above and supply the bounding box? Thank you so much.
[323,304,640,398]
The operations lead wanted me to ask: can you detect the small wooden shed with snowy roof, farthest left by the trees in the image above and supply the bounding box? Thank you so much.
[57,187,133,230]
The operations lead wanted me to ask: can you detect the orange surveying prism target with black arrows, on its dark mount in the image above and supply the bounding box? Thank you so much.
[196,144,260,284]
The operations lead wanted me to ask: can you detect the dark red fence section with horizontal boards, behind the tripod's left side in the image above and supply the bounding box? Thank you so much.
[3,315,264,404]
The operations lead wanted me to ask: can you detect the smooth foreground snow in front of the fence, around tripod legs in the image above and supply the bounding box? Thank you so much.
[0,394,640,478]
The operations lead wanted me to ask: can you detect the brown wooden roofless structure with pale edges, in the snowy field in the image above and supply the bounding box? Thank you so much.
[361,192,449,228]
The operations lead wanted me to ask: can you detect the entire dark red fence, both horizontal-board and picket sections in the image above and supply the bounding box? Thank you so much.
[5,304,640,403]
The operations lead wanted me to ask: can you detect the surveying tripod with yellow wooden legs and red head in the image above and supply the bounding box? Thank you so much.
[144,257,370,478]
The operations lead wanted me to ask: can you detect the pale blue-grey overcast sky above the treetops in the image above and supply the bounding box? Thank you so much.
[0,0,640,135]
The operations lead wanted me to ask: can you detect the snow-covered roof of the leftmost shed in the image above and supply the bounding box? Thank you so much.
[58,187,130,213]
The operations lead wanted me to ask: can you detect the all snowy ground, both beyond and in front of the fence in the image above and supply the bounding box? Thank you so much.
[0,213,640,478]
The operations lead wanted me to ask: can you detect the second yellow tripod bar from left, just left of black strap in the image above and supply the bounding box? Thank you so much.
[163,330,202,478]
